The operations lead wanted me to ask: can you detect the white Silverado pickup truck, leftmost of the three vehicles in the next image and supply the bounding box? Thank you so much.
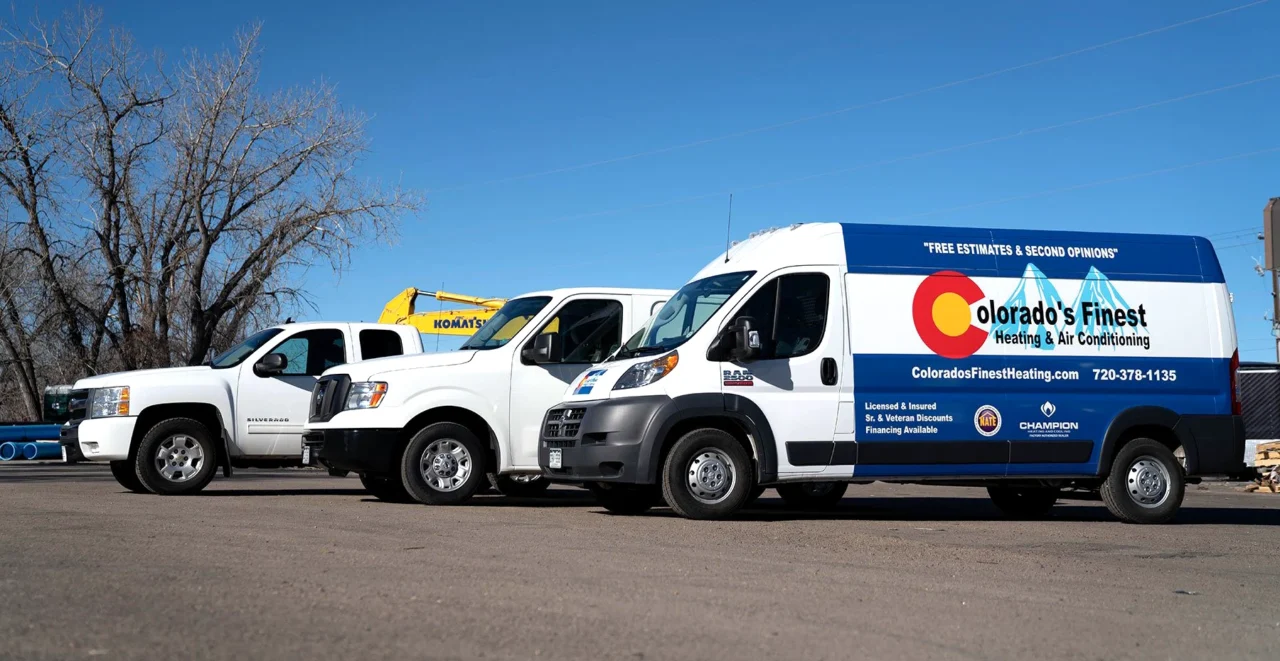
[63,323,422,494]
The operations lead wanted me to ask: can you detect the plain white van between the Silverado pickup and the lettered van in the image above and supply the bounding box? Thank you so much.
[305,288,673,505]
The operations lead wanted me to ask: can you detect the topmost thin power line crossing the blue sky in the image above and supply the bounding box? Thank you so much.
[428,0,1270,193]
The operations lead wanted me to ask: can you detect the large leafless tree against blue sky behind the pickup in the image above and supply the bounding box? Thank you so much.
[0,9,421,417]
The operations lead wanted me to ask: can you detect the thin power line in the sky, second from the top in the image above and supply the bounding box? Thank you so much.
[547,73,1280,223]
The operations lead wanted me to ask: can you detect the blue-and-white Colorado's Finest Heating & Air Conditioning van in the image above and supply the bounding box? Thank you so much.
[539,223,1244,523]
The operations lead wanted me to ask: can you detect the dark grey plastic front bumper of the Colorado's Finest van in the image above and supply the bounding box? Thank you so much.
[538,395,671,484]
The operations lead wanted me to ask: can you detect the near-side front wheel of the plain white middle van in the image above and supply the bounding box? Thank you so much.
[401,423,488,505]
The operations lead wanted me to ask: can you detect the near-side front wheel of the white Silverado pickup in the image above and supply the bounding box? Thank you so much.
[133,418,218,496]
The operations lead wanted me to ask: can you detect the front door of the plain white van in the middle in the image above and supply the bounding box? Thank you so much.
[509,295,630,469]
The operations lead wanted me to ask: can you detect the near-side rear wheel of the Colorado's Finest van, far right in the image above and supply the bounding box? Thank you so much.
[1098,438,1187,524]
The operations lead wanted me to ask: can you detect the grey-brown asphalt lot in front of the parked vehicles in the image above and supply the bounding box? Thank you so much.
[0,464,1280,661]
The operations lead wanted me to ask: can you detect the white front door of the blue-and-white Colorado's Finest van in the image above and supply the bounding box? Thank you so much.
[721,266,845,473]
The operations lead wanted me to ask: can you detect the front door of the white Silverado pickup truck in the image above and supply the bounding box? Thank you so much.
[236,328,352,457]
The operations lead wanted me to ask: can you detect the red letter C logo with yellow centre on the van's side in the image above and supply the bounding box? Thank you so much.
[911,270,987,359]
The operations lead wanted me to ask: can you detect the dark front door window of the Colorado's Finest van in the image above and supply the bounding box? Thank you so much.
[730,273,831,360]
